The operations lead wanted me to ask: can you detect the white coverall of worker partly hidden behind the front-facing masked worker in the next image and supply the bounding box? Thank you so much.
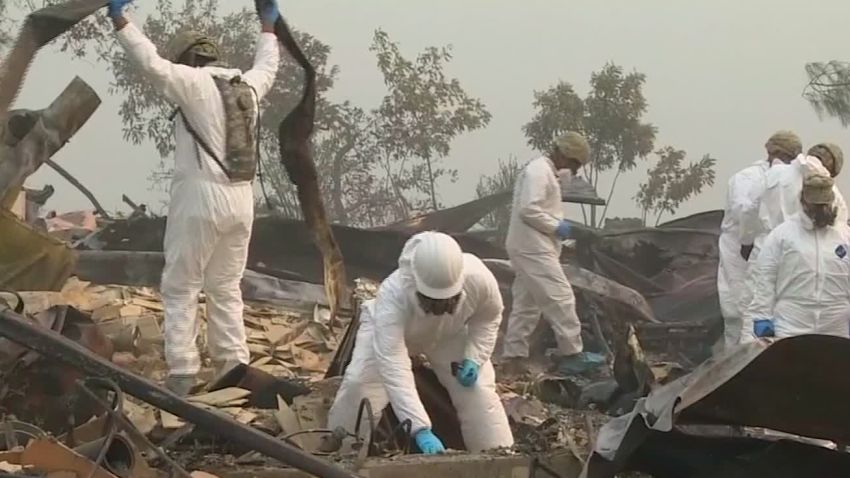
[762,154,848,234]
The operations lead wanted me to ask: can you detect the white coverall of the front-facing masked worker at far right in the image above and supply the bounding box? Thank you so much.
[741,214,850,342]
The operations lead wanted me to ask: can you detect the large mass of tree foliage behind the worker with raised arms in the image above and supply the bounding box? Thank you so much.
[0,0,490,226]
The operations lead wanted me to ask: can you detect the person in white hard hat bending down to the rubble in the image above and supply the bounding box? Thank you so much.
[328,232,513,454]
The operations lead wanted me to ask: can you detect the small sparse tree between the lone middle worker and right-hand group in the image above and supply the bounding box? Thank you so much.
[635,146,717,226]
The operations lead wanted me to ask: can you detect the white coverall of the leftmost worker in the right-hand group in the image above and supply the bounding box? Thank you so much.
[717,160,768,347]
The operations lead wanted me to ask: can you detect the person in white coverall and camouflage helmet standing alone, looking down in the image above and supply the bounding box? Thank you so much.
[502,132,604,375]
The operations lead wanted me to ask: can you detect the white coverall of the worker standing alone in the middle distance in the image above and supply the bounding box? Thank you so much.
[503,156,583,358]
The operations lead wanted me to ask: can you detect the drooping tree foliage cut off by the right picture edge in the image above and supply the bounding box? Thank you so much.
[803,61,850,126]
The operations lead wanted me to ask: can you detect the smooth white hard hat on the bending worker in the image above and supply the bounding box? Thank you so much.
[413,232,463,299]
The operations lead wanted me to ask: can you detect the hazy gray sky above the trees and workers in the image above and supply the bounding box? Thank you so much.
[11,0,850,223]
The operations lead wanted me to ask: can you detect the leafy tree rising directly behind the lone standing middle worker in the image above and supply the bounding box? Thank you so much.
[523,63,656,223]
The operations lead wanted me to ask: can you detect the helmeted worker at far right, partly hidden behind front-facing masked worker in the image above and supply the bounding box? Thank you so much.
[761,143,847,236]
